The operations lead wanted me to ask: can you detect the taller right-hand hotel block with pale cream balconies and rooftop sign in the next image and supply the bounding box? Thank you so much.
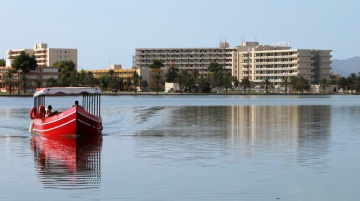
[232,42,331,85]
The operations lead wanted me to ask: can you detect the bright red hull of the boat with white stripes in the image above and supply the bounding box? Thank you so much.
[31,106,102,137]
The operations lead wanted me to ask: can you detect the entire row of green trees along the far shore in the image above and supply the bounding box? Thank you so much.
[0,52,360,94]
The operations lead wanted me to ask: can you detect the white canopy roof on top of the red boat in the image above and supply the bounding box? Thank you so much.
[34,87,101,97]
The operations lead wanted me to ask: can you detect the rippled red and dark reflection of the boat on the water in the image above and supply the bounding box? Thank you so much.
[30,136,102,189]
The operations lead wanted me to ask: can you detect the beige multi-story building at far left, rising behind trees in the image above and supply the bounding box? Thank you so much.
[6,43,77,67]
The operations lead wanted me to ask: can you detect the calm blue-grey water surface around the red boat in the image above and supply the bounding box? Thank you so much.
[0,95,360,200]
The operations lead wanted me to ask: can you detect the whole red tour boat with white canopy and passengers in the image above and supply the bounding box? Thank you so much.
[29,87,103,137]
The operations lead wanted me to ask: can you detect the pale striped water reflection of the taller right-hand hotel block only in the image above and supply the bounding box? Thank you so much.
[231,105,331,166]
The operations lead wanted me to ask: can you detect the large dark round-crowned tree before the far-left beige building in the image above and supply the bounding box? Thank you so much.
[11,51,37,73]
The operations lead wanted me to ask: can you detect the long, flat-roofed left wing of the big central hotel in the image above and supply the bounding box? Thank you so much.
[134,42,237,74]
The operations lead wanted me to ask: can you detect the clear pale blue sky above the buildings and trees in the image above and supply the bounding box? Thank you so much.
[0,0,360,70]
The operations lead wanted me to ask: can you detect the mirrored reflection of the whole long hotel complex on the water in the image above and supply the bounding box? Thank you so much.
[144,105,331,166]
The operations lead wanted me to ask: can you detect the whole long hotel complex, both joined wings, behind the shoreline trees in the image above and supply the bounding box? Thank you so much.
[134,42,331,84]
